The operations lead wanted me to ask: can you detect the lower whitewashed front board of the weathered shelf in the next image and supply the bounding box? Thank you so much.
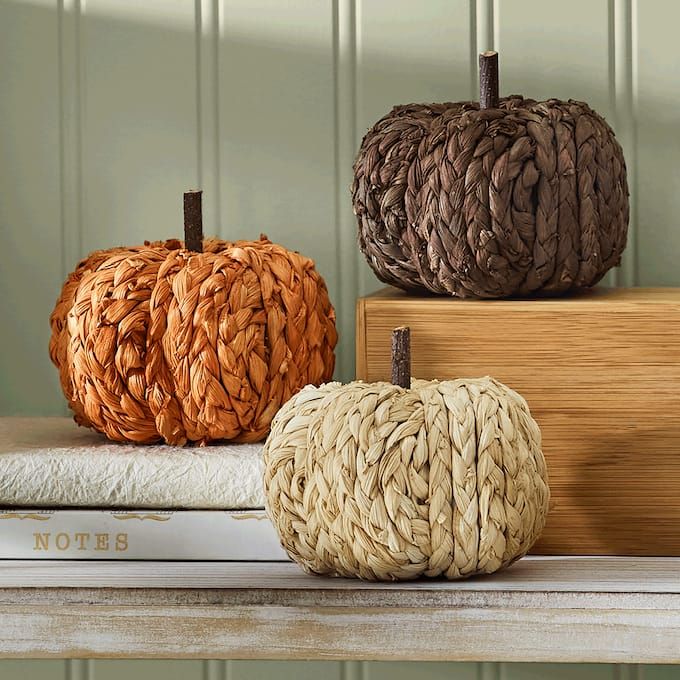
[0,604,680,663]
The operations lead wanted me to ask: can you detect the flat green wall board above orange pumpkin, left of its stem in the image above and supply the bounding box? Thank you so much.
[79,0,198,254]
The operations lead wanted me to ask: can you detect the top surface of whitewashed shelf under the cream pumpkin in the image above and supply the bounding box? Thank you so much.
[0,556,680,597]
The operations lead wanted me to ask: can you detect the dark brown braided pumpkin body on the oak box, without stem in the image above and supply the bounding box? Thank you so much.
[352,95,629,298]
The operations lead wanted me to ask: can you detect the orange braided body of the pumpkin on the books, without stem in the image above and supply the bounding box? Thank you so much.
[50,237,337,444]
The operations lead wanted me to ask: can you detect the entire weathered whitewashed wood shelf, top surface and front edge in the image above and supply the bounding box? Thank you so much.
[0,557,680,663]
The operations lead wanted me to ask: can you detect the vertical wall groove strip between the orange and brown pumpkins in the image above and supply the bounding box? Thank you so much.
[333,0,358,380]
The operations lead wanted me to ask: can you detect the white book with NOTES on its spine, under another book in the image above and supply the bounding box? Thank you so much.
[0,508,288,562]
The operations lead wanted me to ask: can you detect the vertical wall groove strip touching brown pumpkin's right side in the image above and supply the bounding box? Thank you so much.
[612,0,638,286]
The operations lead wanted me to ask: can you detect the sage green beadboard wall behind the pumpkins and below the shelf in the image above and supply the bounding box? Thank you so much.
[0,0,680,680]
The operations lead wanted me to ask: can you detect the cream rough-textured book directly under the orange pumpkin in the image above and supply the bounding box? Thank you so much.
[0,418,264,510]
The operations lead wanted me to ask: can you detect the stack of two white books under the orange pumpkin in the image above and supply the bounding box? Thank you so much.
[0,418,288,561]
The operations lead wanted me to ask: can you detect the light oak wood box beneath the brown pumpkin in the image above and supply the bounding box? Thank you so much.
[357,288,680,556]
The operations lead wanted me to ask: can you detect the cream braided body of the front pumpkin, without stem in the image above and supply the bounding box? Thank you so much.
[264,378,550,580]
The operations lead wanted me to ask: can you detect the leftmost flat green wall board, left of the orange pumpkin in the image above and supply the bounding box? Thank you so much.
[0,0,62,415]
